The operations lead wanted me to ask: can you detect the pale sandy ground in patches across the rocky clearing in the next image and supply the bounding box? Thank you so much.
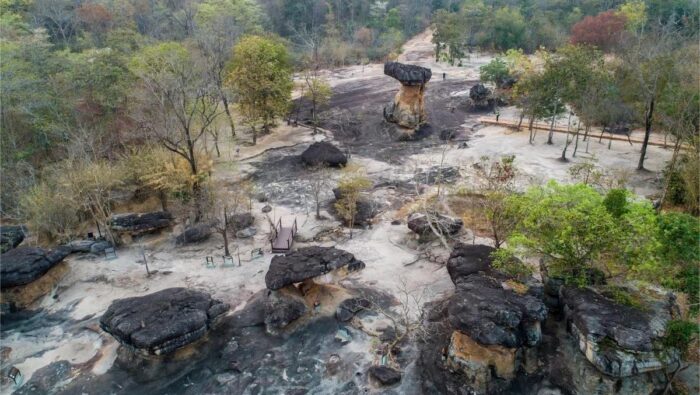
[0,26,671,395]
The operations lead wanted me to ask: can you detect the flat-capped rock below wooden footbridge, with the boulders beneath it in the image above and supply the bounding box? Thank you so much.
[264,246,366,334]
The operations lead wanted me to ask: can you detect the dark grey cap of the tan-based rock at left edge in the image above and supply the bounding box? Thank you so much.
[0,246,72,289]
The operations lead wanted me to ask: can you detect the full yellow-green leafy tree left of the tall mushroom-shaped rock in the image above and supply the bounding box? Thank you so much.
[227,36,293,144]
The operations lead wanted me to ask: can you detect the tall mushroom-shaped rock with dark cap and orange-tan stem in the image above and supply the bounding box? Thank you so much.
[384,62,432,130]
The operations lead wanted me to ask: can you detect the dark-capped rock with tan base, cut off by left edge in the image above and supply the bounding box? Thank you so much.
[0,246,71,309]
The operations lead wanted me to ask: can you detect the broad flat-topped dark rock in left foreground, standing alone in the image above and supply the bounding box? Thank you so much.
[100,288,229,355]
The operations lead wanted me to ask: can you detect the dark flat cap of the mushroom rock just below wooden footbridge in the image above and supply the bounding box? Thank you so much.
[265,246,365,290]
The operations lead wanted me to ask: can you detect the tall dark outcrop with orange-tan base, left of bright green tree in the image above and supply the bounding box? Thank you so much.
[421,244,547,394]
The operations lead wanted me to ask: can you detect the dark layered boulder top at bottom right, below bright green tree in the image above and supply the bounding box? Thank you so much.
[560,287,680,377]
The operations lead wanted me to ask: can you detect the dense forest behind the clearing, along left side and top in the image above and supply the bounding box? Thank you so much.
[0,0,699,222]
